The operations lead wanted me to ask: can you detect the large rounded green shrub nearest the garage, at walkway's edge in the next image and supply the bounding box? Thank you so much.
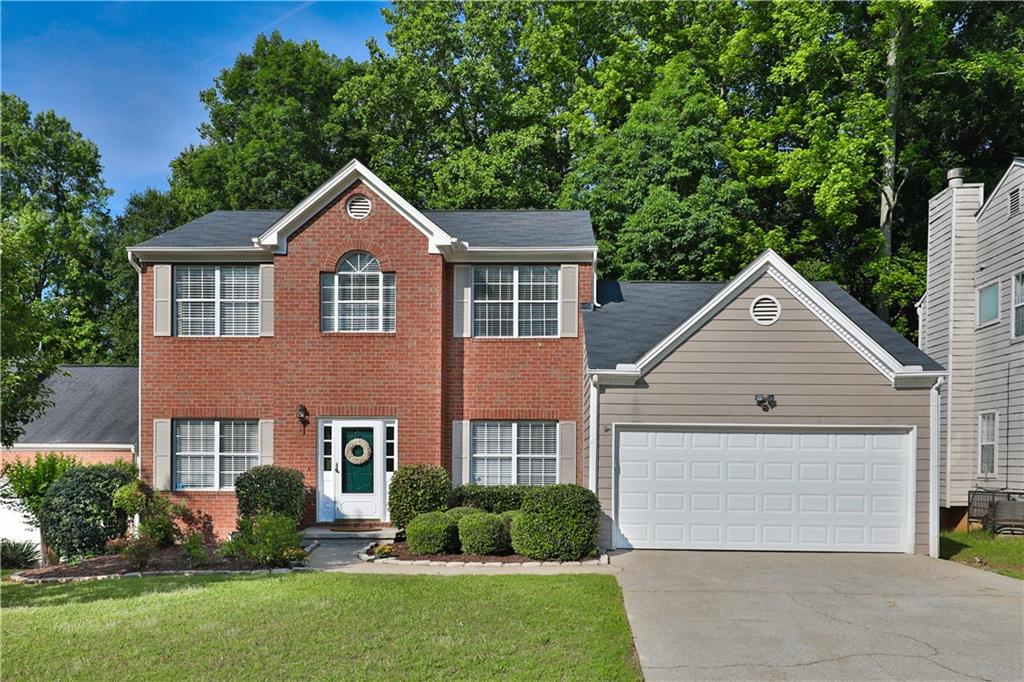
[512,483,601,561]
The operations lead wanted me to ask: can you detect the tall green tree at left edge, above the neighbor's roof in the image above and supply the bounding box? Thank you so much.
[0,93,111,366]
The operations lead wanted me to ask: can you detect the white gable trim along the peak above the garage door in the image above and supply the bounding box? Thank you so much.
[617,249,918,382]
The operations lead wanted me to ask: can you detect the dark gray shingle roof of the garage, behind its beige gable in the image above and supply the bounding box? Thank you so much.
[584,282,942,370]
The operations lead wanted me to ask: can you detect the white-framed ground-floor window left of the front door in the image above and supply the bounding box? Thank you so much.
[173,419,259,491]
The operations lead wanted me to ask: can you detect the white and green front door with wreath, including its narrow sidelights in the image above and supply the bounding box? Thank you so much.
[316,419,387,521]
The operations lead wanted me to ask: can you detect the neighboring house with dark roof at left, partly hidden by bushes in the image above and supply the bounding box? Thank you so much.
[0,366,138,542]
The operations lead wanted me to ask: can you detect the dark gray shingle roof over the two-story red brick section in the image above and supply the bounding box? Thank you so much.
[135,210,595,248]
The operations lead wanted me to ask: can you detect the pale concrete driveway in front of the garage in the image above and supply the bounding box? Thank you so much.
[611,551,1024,680]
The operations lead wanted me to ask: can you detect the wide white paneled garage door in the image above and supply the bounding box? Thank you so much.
[616,429,913,552]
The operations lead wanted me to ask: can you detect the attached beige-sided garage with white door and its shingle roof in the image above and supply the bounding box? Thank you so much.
[584,251,945,553]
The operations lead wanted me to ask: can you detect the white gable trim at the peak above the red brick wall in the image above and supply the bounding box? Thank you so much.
[253,159,455,254]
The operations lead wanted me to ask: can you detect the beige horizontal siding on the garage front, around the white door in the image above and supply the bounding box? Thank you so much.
[598,275,930,552]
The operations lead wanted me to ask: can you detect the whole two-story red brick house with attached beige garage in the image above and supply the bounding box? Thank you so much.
[129,161,944,552]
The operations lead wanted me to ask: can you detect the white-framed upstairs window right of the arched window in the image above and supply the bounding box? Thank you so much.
[473,265,559,337]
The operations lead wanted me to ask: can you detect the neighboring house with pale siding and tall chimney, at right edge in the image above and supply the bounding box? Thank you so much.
[918,158,1024,526]
